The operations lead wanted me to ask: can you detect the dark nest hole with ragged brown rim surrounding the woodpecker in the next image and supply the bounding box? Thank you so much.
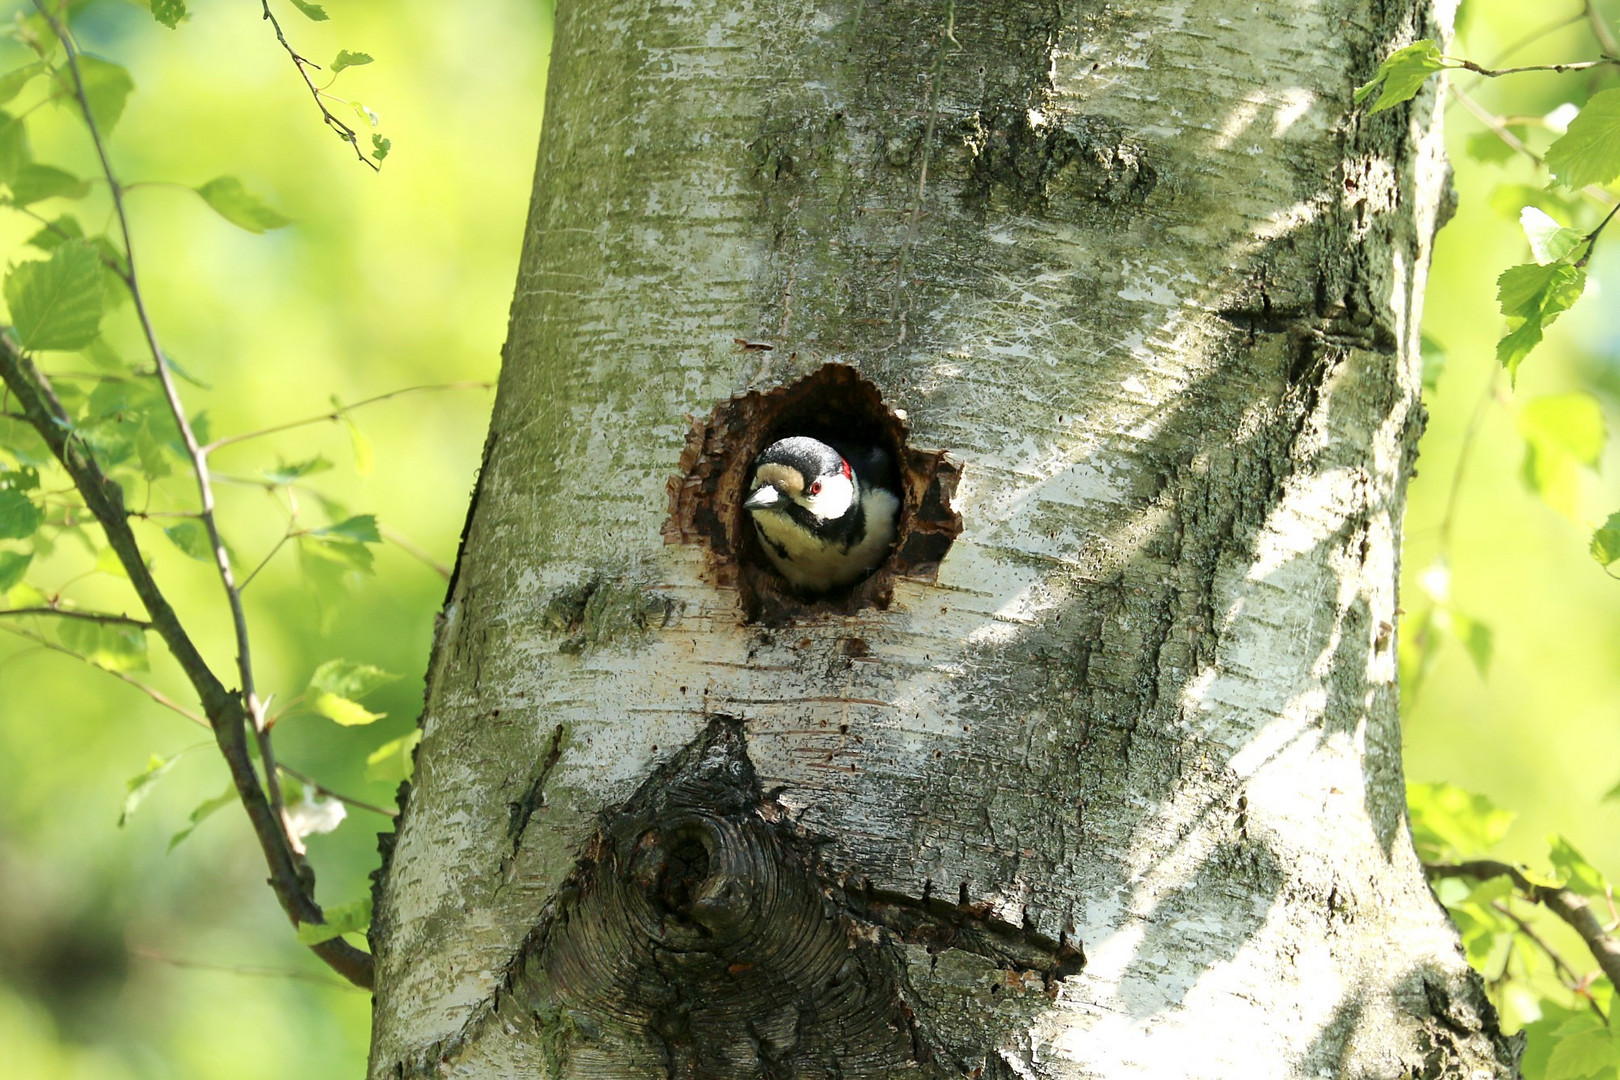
[664,364,962,623]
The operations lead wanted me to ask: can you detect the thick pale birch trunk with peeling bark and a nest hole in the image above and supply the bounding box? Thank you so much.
[371,0,1516,1080]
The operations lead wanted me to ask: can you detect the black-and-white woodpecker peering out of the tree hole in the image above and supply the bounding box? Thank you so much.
[742,436,901,593]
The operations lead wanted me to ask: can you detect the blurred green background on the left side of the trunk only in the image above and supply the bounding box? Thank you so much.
[0,0,551,1080]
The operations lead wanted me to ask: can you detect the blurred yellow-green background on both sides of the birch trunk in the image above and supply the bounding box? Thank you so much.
[0,0,1620,1080]
